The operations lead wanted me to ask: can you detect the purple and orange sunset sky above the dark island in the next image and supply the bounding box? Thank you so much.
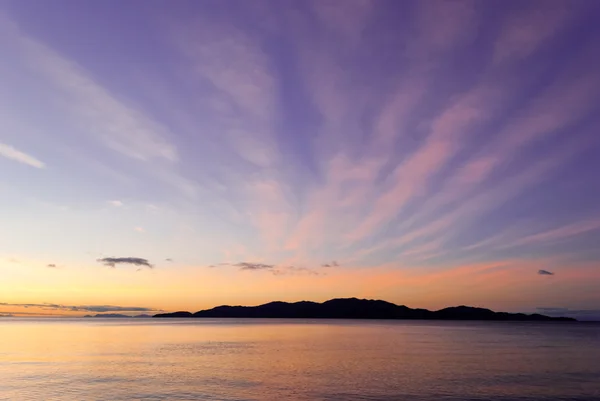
[0,0,600,318]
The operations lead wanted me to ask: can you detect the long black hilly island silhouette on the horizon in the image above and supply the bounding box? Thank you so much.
[154,298,576,322]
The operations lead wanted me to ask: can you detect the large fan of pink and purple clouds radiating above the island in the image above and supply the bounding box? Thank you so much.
[151,1,600,276]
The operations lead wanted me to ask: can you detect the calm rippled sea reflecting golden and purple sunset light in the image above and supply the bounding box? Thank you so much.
[0,318,600,401]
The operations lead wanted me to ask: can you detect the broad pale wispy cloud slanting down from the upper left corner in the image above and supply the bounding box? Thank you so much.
[0,13,204,198]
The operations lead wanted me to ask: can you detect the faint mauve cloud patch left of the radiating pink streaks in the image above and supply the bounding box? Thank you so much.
[174,18,281,167]
